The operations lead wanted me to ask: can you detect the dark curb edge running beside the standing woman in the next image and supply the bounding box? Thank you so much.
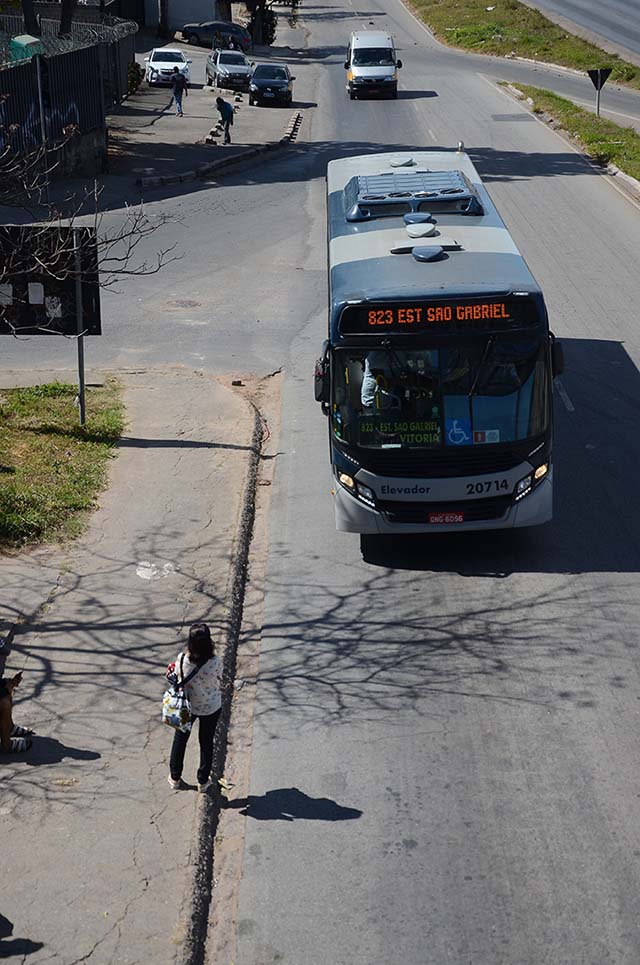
[176,402,262,965]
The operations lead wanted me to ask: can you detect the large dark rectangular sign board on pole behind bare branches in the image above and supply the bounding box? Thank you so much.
[0,225,101,336]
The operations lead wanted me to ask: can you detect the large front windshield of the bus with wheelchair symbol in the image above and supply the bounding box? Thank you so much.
[331,334,550,449]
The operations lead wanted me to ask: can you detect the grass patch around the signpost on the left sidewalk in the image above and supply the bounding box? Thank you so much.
[0,379,124,549]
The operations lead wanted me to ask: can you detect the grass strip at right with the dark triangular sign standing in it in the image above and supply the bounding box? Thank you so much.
[511,84,640,181]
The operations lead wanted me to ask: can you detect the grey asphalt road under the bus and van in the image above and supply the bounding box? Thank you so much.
[1,0,640,965]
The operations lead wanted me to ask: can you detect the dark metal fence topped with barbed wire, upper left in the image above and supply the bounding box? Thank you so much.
[0,15,138,153]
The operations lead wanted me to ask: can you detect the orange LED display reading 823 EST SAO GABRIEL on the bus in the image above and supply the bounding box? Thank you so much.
[340,298,538,335]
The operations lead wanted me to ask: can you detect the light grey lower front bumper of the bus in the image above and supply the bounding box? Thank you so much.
[334,469,553,535]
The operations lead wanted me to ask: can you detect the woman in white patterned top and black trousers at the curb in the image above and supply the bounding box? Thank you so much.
[167,623,222,791]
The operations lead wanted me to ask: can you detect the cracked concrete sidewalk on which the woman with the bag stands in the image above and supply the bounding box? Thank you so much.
[0,368,255,965]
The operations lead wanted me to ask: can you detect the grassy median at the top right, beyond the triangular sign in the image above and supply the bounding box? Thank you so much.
[410,0,640,88]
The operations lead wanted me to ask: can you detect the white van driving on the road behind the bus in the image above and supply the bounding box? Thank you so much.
[344,30,402,100]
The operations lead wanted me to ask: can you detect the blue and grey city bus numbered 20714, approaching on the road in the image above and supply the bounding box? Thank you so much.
[314,150,563,534]
